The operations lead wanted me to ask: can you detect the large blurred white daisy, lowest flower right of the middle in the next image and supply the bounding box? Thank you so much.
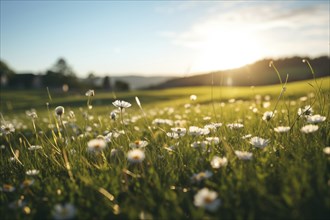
[194,188,221,211]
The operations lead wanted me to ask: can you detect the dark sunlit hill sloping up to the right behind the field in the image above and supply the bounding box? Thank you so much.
[149,56,330,89]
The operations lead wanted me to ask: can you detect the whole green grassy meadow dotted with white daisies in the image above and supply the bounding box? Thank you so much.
[0,77,330,219]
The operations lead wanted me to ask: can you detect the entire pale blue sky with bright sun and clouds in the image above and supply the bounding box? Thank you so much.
[0,0,330,77]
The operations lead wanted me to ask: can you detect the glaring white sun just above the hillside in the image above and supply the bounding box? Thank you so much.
[191,31,262,72]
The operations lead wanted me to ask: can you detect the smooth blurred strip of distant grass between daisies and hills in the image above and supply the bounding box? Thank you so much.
[0,77,330,113]
